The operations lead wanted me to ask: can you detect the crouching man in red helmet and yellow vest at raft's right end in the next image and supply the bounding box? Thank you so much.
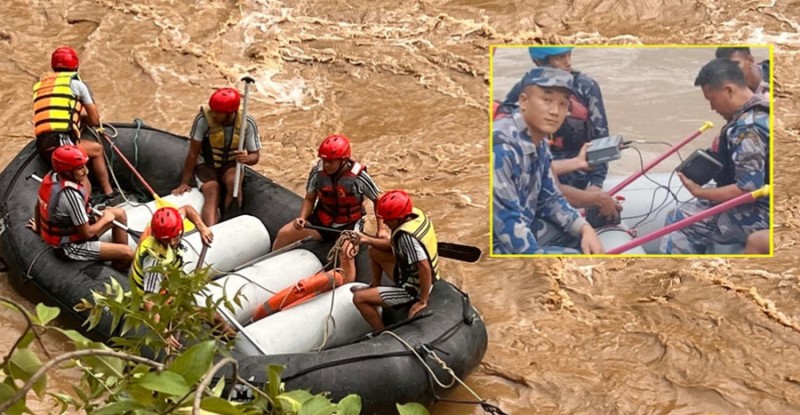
[353,190,439,330]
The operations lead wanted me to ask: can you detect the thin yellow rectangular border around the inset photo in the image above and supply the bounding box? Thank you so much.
[488,43,775,259]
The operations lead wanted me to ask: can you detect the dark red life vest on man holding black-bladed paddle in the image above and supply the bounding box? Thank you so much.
[314,162,367,226]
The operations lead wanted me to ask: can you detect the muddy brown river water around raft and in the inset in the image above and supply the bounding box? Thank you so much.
[0,0,800,415]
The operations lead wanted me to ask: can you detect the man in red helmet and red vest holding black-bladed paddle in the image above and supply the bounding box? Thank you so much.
[272,134,389,249]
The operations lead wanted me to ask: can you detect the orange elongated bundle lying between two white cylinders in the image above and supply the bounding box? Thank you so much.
[253,270,344,321]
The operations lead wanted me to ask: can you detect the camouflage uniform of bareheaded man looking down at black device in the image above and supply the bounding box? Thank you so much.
[661,96,769,254]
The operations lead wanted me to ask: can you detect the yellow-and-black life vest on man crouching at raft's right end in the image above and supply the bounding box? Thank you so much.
[392,208,439,295]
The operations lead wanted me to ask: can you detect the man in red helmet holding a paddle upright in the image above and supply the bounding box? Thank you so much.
[172,88,261,226]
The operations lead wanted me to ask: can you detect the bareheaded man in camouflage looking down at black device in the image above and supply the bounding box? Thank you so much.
[660,58,770,254]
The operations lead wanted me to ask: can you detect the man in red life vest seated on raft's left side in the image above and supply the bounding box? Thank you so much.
[28,145,133,271]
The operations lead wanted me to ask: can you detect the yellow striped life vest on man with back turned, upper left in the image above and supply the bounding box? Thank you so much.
[33,72,83,137]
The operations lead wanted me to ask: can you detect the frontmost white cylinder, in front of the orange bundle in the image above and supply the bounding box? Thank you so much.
[235,282,372,356]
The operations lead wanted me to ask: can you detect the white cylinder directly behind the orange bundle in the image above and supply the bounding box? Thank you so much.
[202,249,322,324]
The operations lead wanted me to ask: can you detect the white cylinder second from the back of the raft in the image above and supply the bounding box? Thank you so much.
[182,215,271,275]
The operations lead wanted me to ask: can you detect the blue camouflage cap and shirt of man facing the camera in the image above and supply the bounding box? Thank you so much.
[492,68,586,254]
